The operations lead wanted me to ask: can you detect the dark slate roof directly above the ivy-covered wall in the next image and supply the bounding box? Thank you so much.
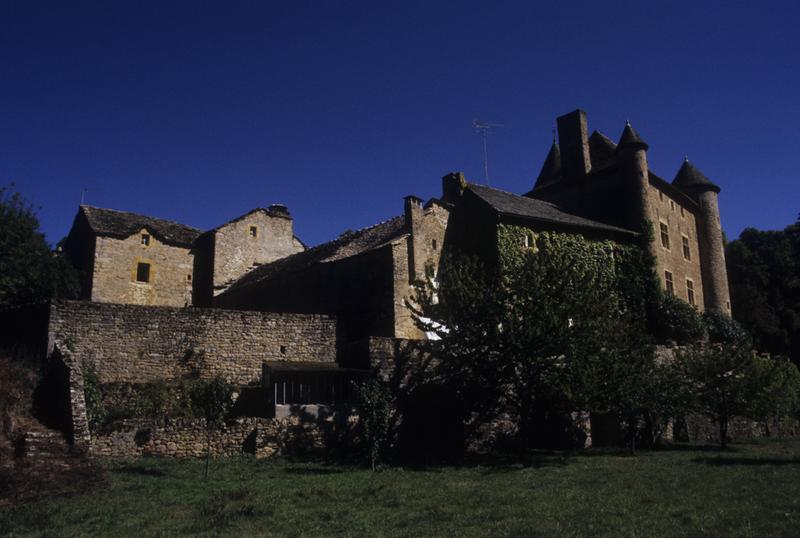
[467,183,637,236]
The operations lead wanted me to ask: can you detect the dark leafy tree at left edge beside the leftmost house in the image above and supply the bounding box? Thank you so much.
[0,186,80,306]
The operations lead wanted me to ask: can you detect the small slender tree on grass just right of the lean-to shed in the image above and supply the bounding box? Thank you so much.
[355,379,392,471]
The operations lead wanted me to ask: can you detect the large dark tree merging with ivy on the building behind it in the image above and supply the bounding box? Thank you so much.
[416,226,643,449]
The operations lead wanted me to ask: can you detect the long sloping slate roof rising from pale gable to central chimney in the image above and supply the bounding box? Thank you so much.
[226,216,408,292]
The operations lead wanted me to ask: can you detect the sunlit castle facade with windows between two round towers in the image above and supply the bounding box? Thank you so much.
[645,183,704,310]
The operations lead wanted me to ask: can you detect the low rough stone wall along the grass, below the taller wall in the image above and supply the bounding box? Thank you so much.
[91,415,358,459]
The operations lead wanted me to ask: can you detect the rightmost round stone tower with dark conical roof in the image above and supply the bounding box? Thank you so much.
[672,159,731,315]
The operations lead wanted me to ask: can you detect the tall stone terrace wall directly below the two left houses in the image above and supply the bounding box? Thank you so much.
[48,301,336,384]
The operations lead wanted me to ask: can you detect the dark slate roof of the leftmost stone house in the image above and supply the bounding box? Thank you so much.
[80,205,203,247]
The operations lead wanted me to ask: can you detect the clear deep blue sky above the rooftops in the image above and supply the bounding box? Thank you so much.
[0,0,800,245]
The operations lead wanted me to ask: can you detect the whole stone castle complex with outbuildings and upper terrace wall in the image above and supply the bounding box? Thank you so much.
[3,110,730,453]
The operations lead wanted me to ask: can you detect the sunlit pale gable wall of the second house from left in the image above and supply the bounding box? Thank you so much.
[213,209,303,295]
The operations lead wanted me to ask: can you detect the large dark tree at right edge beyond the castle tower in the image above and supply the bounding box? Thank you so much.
[727,220,800,364]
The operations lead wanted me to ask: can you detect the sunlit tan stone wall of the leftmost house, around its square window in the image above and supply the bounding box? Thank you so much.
[91,228,194,306]
